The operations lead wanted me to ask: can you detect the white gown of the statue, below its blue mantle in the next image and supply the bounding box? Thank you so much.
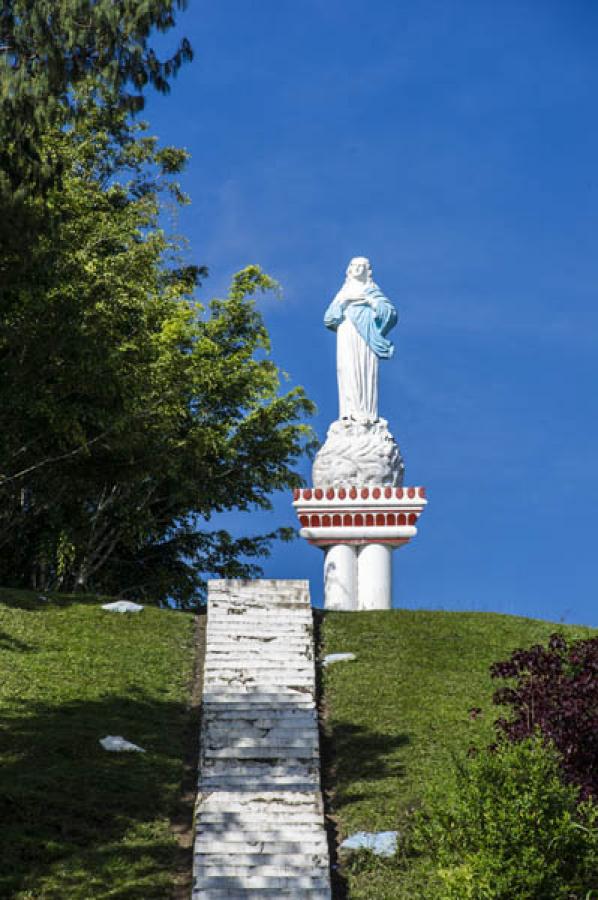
[336,318,378,422]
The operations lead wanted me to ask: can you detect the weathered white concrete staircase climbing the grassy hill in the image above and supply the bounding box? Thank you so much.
[192,581,331,900]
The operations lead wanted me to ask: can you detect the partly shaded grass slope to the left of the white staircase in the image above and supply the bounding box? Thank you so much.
[0,590,198,900]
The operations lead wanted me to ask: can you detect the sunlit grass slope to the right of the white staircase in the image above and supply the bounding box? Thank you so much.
[321,610,595,900]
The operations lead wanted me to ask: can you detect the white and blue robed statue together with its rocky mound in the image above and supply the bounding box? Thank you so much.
[312,256,405,488]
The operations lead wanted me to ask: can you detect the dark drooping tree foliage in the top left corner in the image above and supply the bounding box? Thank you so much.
[0,0,192,190]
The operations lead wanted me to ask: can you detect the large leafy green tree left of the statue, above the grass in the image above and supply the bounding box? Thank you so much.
[0,96,312,604]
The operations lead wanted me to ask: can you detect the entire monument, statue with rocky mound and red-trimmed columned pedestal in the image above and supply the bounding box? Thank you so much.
[293,256,427,610]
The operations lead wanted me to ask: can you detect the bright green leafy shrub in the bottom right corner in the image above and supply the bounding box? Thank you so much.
[414,735,598,900]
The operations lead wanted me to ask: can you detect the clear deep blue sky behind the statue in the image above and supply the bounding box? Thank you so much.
[147,0,598,625]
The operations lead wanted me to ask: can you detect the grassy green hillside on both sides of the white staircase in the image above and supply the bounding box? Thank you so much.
[0,590,595,900]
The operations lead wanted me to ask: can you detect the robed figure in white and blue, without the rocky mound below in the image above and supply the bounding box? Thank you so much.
[324,256,397,424]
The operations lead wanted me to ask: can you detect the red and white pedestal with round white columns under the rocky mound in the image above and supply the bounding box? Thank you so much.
[293,487,427,611]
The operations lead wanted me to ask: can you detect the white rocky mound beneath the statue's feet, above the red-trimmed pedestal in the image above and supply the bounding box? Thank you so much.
[312,419,405,488]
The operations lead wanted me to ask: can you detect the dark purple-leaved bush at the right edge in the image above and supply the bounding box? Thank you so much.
[490,634,598,798]
